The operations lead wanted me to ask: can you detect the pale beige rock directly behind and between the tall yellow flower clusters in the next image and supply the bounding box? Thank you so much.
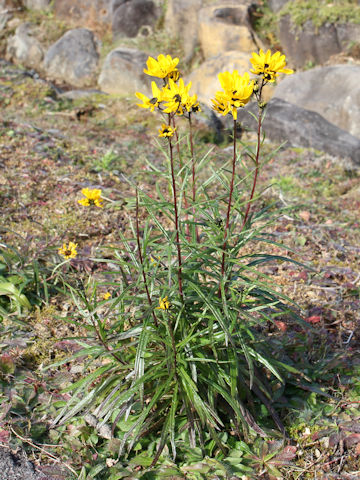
[186,51,251,106]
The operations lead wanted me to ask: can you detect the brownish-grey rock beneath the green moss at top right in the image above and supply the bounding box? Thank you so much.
[279,15,360,67]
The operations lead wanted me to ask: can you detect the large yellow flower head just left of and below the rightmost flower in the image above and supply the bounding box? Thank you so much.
[213,70,254,120]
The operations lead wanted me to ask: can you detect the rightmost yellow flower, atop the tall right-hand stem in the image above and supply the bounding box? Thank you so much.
[250,50,294,82]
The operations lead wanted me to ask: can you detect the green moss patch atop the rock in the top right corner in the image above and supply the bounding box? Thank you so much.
[279,0,360,27]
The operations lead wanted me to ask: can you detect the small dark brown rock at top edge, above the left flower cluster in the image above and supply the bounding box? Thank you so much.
[112,0,160,38]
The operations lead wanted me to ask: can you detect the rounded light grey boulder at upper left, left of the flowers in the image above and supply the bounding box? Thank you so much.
[44,28,99,87]
